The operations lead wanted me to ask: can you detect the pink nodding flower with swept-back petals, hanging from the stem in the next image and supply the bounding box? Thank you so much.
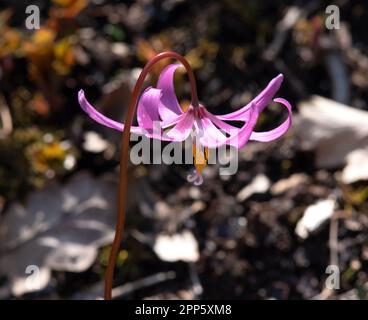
[78,64,292,184]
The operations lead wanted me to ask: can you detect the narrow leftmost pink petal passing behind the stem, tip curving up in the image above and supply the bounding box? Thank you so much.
[78,90,142,134]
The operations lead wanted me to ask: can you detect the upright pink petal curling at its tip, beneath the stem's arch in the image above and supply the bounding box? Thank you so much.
[157,64,183,121]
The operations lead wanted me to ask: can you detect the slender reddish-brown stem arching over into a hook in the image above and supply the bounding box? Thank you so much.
[104,51,199,300]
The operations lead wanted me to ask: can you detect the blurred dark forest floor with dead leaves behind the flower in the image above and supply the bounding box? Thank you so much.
[0,0,368,299]
